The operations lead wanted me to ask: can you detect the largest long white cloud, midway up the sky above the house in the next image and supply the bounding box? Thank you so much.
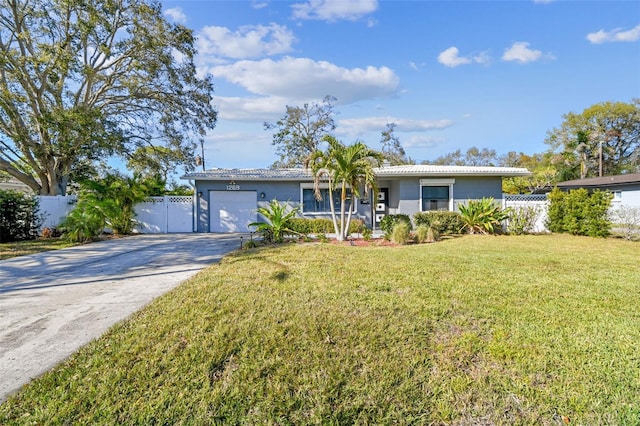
[208,57,399,104]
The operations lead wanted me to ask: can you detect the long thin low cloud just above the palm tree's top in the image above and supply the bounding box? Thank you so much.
[338,116,453,135]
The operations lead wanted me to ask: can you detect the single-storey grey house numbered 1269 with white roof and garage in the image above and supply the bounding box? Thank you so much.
[182,165,530,232]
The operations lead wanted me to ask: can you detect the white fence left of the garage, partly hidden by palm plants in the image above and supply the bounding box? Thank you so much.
[38,195,194,234]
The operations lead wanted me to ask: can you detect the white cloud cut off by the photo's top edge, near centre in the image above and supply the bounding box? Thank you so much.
[291,0,378,22]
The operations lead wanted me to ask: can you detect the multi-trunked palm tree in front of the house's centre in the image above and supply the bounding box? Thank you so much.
[305,135,384,241]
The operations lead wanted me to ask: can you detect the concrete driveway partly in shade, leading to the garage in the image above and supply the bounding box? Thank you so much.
[0,234,246,402]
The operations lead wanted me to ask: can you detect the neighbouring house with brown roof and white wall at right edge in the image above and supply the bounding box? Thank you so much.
[557,173,640,208]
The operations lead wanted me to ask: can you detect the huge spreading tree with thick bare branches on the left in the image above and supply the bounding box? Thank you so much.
[0,0,217,195]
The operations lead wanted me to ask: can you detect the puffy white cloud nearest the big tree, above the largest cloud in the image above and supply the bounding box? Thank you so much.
[196,23,295,62]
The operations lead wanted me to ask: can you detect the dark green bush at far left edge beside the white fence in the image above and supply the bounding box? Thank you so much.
[0,190,42,243]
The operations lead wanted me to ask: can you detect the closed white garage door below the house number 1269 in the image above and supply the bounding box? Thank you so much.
[209,191,258,232]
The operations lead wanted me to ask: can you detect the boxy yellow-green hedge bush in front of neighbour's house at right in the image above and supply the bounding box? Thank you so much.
[547,188,612,237]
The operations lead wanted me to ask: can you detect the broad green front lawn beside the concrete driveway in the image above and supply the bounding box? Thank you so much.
[0,236,640,425]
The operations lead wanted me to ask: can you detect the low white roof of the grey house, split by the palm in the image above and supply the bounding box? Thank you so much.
[181,164,531,181]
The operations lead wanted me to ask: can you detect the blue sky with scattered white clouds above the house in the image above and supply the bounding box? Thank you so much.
[162,0,640,168]
